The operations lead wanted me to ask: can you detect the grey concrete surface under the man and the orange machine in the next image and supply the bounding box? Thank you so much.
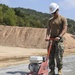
[0,55,75,75]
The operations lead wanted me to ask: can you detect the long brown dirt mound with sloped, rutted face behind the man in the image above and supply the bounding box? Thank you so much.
[0,25,75,48]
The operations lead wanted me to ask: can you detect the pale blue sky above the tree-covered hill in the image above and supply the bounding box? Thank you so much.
[0,0,75,20]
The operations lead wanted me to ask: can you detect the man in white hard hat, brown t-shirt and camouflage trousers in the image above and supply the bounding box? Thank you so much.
[46,3,68,75]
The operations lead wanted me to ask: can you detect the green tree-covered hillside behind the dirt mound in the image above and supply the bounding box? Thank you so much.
[0,4,75,34]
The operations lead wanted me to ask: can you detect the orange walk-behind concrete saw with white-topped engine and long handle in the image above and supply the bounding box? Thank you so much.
[27,38,54,75]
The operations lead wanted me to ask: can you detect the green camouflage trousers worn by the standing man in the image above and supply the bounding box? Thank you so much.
[48,41,64,70]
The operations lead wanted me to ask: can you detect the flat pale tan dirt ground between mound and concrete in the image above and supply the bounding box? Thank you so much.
[0,46,75,67]
